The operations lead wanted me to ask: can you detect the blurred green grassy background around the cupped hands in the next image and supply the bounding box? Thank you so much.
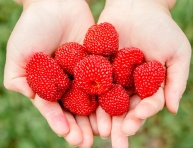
[0,0,193,148]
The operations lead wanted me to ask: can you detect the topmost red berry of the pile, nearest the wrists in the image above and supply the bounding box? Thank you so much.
[83,22,119,56]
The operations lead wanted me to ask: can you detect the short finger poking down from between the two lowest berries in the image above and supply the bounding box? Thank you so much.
[96,106,111,139]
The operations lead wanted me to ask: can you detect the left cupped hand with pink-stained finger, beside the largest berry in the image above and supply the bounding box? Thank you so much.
[4,0,94,148]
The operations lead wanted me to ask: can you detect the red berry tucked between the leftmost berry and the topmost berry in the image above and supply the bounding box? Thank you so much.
[55,42,86,75]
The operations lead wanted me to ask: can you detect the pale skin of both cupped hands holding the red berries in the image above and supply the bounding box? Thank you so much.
[4,0,191,148]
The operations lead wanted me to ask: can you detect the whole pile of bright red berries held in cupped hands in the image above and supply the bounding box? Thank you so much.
[26,22,165,116]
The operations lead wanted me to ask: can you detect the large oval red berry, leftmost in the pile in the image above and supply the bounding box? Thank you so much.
[26,52,69,102]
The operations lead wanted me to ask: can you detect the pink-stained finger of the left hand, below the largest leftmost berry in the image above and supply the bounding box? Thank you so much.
[31,95,70,136]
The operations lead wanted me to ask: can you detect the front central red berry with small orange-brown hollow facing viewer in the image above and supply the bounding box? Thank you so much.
[74,55,112,95]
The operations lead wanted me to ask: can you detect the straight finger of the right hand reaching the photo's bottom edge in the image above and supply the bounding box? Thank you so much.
[111,115,129,148]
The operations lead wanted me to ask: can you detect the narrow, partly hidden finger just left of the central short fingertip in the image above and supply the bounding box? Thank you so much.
[89,113,99,136]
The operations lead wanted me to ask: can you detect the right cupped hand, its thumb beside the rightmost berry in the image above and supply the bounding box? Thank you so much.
[96,0,191,148]
